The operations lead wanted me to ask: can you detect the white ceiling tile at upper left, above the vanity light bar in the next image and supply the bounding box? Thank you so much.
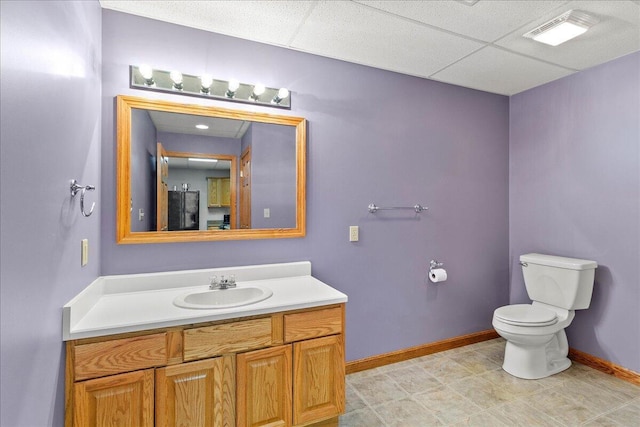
[100,0,314,46]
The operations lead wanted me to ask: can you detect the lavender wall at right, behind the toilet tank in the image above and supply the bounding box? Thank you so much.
[509,53,640,372]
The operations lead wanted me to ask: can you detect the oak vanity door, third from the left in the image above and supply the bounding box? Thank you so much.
[236,345,291,427]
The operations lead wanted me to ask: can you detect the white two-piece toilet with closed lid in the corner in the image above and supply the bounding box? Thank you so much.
[492,253,598,379]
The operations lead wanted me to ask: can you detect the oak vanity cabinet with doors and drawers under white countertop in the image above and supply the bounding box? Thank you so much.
[65,304,345,427]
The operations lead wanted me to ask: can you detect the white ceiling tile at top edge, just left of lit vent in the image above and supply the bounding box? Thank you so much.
[357,0,564,42]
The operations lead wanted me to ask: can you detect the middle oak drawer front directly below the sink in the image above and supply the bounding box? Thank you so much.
[183,317,273,361]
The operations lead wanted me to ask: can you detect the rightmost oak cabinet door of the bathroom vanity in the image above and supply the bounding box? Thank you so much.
[293,335,345,425]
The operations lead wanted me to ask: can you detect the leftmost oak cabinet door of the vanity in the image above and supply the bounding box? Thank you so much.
[73,369,153,427]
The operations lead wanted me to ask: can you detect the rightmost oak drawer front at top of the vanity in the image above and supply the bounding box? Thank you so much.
[284,307,342,342]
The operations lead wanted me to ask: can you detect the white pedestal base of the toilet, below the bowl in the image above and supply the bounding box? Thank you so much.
[502,329,571,380]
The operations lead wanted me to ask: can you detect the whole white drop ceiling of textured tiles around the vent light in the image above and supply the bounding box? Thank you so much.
[100,0,640,95]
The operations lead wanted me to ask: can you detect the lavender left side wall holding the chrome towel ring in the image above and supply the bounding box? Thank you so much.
[0,1,101,427]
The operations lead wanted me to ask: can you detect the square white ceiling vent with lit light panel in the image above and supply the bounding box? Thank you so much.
[522,10,599,46]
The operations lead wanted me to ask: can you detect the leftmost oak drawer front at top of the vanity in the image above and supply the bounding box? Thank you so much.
[74,332,167,381]
